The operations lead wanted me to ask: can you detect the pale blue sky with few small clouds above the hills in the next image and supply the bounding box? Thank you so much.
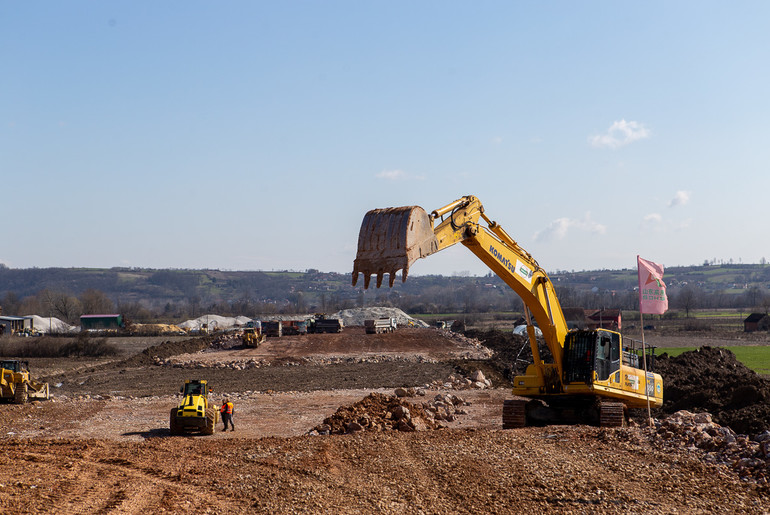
[0,0,770,275]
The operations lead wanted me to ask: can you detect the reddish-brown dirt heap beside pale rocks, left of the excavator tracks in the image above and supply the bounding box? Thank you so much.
[314,392,440,434]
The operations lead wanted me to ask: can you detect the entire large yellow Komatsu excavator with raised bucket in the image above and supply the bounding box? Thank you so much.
[353,196,663,429]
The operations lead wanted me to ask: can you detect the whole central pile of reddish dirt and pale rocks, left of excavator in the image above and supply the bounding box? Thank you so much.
[310,389,467,435]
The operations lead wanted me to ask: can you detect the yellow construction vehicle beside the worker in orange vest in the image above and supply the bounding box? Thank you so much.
[169,379,219,435]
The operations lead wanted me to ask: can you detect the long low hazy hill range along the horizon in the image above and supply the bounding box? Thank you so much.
[0,264,770,318]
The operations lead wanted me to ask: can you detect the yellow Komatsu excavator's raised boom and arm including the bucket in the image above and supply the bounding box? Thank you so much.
[353,195,567,370]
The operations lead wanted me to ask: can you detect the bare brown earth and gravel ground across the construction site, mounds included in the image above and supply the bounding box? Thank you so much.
[0,327,770,513]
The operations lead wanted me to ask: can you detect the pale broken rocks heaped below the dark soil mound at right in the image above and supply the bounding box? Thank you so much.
[644,410,770,486]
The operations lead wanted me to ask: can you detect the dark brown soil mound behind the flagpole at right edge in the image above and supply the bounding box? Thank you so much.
[655,347,770,435]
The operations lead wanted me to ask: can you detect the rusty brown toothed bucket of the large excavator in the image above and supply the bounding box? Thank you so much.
[353,206,438,288]
